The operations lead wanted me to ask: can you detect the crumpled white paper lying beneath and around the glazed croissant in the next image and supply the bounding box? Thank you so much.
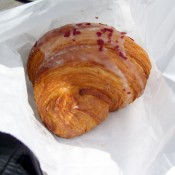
[0,0,175,175]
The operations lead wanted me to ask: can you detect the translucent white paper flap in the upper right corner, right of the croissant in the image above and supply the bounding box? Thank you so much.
[127,0,175,92]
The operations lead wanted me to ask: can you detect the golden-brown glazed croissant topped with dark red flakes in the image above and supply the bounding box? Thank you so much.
[27,23,151,138]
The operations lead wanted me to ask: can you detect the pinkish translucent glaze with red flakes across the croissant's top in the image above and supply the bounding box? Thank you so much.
[32,23,145,103]
